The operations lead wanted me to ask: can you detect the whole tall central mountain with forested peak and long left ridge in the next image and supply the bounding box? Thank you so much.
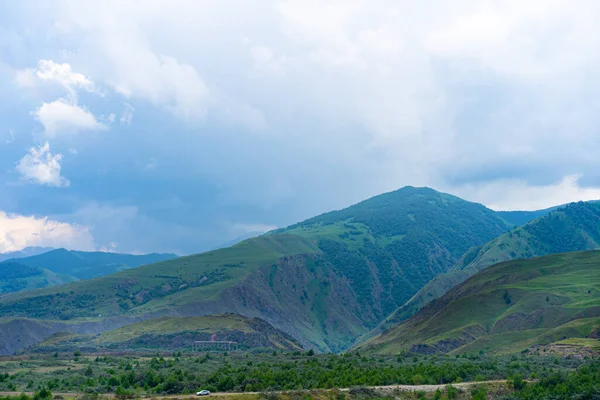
[0,187,510,351]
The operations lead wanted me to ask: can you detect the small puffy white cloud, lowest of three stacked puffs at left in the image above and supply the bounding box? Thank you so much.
[17,142,70,187]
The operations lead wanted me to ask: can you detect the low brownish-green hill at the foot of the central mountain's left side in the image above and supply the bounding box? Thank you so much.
[29,314,302,353]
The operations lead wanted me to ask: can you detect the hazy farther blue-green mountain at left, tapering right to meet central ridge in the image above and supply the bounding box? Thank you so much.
[12,249,177,279]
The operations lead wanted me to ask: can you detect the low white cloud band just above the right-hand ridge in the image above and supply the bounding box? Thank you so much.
[452,175,600,210]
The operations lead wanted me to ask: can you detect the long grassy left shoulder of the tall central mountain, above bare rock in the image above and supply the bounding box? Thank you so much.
[0,235,318,319]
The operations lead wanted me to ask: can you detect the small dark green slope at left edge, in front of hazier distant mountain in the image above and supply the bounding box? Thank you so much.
[0,260,77,294]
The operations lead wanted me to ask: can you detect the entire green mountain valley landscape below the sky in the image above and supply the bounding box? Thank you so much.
[0,187,600,400]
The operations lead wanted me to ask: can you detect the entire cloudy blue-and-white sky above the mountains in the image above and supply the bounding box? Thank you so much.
[0,0,600,254]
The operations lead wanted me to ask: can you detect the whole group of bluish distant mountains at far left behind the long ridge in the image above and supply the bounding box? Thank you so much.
[0,248,176,294]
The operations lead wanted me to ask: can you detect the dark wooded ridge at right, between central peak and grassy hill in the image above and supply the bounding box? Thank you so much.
[361,202,600,340]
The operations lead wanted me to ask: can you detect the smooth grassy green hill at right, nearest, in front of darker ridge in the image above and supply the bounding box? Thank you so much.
[357,251,600,354]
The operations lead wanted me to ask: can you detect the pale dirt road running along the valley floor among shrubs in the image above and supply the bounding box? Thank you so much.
[0,380,506,399]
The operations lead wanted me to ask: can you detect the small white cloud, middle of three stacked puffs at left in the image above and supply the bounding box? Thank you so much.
[34,99,106,137]
